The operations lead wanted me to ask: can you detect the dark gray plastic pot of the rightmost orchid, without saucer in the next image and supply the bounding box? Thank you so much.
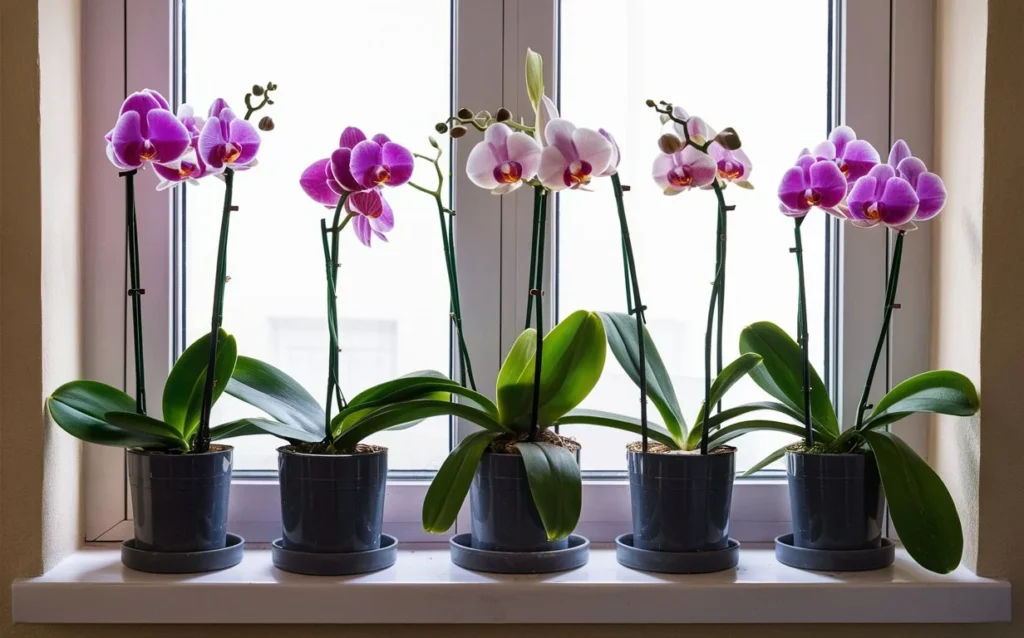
[785,451,884,550]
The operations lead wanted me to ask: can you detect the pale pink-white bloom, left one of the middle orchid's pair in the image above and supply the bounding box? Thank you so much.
[466,123,541,195]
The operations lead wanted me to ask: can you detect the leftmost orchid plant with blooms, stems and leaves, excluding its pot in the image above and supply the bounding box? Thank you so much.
[46,82,276,454]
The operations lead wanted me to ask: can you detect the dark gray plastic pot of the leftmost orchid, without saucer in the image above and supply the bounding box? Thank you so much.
[128,445,232,552]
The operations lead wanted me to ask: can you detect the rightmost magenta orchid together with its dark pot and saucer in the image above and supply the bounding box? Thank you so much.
[739,126,980,573]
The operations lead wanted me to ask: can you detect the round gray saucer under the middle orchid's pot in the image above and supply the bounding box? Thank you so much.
[449,534,590,573]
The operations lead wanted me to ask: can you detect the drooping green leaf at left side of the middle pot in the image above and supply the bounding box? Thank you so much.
[423,431,499,534]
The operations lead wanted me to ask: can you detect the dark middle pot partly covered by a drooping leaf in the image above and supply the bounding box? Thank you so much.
[469,452,568,552]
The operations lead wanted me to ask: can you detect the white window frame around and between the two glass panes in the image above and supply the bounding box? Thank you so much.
[82,0,934,543]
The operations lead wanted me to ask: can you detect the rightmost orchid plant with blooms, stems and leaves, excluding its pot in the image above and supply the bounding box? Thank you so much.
[739,127,980,572]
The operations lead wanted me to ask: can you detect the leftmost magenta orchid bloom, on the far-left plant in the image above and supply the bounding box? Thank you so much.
[106,89,189,171]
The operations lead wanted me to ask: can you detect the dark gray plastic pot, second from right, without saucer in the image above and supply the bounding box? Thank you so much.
[627,448,736,552]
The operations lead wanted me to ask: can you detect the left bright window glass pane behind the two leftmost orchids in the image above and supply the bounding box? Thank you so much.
[183,0,452,470]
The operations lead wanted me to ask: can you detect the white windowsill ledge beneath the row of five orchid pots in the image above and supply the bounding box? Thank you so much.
[12,544,1011,624]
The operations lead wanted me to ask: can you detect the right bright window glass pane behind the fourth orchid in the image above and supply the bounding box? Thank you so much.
[558,0,828,470]
